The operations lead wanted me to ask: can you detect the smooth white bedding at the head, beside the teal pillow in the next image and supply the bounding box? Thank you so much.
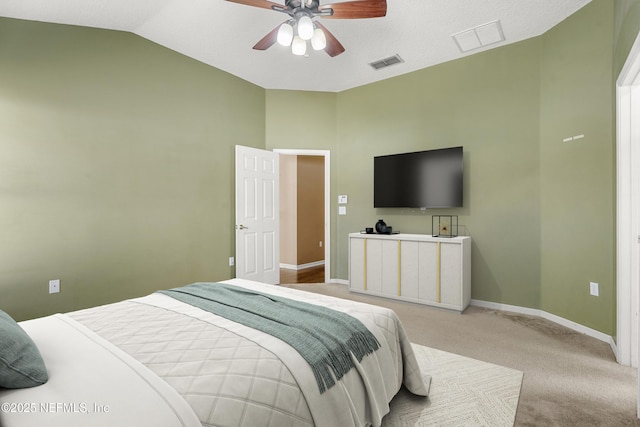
[0,314,201,427]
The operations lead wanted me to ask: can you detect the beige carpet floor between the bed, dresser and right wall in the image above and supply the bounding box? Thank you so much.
[287,283,640,427]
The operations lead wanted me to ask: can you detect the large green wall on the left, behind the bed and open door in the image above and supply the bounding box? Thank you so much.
[0,19,265,319]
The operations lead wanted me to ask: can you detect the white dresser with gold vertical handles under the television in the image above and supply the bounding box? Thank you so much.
[349,233,471,312]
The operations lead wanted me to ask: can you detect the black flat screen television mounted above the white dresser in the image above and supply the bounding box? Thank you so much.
[373,147,463,208]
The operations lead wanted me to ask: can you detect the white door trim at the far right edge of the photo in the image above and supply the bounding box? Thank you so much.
[616,30,640,372]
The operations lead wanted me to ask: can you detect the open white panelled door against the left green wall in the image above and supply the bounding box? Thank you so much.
[236,145,280,284]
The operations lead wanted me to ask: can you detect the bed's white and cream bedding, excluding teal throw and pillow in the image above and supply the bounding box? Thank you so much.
[0,279,430,427]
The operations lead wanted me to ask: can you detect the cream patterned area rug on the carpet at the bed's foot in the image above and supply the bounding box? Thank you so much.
[382,344,523,427]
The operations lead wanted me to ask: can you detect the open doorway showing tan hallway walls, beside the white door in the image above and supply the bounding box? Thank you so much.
[273,149,331,284]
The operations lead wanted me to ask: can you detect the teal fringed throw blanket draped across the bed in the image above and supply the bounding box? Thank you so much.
[158,283,380,393]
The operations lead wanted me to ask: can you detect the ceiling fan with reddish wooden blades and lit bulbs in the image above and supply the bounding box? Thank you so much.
[227,0,387,57]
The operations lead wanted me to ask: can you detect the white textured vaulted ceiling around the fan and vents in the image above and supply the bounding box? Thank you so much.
[0,0,591,92]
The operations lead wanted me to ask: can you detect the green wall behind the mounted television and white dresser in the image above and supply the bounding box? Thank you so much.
[338,39,540,307]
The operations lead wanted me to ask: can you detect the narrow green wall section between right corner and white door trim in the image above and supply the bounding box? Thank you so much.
[540,1,616,335]
